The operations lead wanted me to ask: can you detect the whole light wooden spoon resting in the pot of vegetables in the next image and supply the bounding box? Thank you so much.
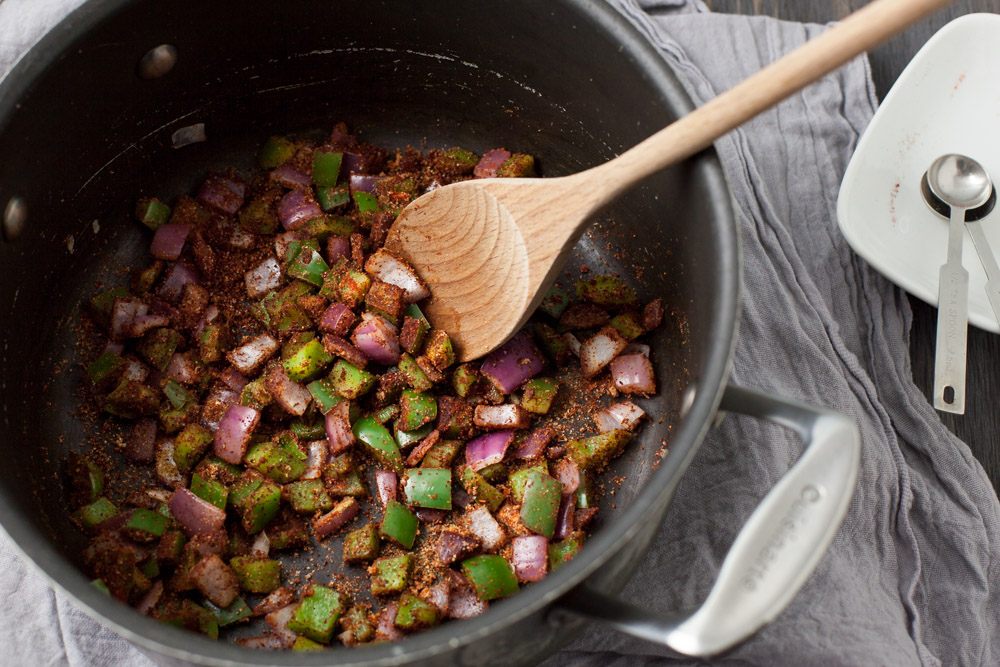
[386,0,951,361]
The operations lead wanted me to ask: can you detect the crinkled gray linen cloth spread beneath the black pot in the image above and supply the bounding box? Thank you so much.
[0,0,1000,667]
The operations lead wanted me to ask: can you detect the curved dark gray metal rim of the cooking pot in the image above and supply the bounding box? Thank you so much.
[0,0,741,667]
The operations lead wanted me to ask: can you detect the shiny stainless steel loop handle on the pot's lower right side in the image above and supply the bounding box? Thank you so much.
[554,385,861,657]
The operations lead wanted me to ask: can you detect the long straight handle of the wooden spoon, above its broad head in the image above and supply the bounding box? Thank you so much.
[578,0,952,202]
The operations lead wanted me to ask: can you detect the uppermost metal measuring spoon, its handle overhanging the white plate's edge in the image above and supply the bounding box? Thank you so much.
[927,154,1000,414]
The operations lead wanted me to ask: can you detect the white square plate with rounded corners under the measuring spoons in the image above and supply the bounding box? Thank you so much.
[837,14,1000,332]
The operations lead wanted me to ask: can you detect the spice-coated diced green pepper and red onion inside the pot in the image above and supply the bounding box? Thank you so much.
[68,124,663,650]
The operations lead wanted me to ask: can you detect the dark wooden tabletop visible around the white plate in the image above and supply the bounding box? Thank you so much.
[706,0,1000,492]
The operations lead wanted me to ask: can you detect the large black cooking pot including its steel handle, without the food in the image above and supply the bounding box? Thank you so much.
[0,0,859,665]
